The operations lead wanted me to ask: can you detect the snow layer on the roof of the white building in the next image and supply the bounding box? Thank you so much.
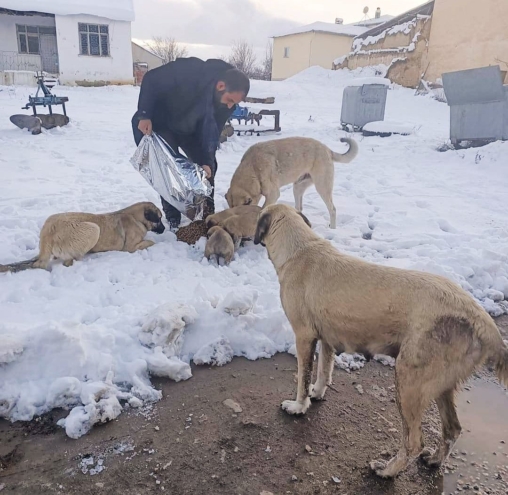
[0,0,135,21]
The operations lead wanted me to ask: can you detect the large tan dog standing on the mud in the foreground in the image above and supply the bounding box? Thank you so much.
[254,205,508,477]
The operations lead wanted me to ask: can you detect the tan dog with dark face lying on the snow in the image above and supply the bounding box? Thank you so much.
[0,202,164,272]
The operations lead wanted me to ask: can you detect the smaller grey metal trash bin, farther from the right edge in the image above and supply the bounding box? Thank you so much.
[340,84,388,130]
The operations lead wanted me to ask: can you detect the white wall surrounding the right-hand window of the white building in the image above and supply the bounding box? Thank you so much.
[56,15,134,85]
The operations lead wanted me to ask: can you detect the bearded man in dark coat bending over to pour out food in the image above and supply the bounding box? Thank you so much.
[132,57,250,229]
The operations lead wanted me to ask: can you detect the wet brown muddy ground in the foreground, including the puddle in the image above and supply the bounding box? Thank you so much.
[0,318,508,495]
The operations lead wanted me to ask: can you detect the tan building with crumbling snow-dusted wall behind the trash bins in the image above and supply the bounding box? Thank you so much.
[334,0,508,87]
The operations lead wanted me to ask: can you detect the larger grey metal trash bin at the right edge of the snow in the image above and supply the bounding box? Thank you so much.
[443,65,508,145]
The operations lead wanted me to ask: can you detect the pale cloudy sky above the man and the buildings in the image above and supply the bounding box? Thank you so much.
[132,0,425,58]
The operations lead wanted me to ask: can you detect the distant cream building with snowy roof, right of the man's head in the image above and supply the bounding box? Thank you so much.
[272,12,392,81]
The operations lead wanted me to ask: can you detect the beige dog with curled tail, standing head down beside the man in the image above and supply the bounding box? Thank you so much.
[226,137,358,229]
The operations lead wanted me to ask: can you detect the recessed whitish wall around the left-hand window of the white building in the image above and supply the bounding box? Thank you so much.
[0,14,55,71]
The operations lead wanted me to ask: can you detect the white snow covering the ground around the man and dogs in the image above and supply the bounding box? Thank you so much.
[0,68,508,437]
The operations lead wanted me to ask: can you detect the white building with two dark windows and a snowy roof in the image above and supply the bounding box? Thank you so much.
[0,0,134,85]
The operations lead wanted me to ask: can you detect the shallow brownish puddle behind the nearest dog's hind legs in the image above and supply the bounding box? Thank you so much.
[443,379,508,495]
